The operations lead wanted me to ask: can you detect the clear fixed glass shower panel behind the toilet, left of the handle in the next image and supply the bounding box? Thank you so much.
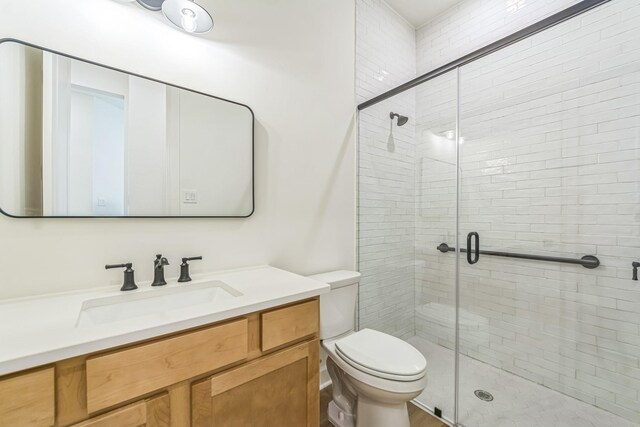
[358,68,458,421]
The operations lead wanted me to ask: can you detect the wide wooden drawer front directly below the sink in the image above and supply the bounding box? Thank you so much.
[87,319,248,413]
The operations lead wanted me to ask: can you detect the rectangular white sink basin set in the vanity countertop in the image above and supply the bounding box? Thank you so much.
[76,280,242,328]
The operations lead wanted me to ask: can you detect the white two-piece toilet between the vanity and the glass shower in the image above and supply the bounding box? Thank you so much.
[311,271,427,427]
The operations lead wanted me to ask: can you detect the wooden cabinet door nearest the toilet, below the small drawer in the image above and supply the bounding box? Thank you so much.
[191,340,320,427]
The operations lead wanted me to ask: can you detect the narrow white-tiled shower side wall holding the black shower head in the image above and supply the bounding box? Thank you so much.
[356,0,416,338]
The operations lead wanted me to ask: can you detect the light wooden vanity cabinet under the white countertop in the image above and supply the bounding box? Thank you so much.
[0,298,320,427]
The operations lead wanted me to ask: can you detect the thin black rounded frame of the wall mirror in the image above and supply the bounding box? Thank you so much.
[0,38,256,219]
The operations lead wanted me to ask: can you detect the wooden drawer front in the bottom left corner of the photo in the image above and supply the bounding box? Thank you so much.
[0,368,55,427]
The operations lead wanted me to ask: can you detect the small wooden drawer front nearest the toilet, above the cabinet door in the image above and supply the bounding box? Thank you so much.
[262,300,320,351]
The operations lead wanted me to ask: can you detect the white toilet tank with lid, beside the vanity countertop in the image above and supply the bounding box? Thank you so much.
[310,270,361,340]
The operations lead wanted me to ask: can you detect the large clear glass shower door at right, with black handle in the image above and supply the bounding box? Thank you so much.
[456,0,640,426]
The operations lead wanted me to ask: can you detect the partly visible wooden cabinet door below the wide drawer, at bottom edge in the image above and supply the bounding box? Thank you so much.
[73,393,171,427]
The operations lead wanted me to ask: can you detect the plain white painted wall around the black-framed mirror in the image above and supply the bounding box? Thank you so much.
[0,0,355,298]
